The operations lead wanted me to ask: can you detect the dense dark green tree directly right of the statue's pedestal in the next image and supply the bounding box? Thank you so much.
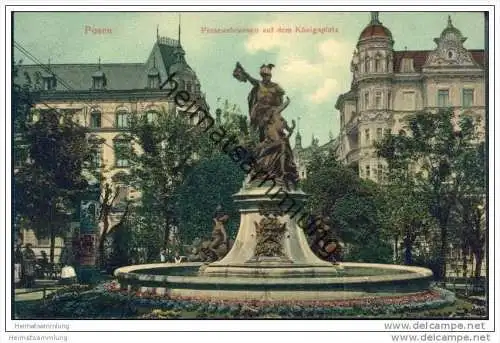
[303,154,392,262]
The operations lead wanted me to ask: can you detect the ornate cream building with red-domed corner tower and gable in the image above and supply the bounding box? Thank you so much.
[335,12,485,181]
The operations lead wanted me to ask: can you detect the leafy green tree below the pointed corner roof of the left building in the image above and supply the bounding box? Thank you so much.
[130,108,203,253]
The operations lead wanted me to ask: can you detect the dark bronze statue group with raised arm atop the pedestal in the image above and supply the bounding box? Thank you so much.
[233,62,298,186]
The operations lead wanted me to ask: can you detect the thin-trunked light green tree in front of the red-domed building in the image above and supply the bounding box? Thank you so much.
[377,109,484,278]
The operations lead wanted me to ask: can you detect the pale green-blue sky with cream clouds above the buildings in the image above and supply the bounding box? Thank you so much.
[13,12,485,146]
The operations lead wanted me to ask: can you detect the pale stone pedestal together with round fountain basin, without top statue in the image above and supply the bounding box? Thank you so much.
[115,184,432,301]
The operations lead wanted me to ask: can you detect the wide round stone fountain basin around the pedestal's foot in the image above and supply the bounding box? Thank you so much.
[114,262,432,301]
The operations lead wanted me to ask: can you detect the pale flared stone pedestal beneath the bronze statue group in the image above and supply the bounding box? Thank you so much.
[200,184,337,277]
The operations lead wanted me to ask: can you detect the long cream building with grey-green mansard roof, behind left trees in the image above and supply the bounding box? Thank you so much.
[14,26,209,260]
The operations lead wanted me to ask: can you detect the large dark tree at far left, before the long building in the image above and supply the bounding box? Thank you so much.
[14,109,92,262]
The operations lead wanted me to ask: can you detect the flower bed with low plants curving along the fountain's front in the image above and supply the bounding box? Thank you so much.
[15,282,455,319]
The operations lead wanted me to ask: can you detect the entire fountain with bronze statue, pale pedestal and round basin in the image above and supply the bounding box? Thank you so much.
[115,63,432,302]
